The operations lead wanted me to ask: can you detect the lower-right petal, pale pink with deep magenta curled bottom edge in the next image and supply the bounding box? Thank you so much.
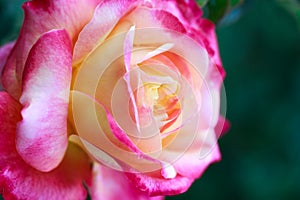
[126,132,220,196]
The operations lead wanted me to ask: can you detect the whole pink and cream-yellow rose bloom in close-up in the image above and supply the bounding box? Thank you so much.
[0,0,225,199]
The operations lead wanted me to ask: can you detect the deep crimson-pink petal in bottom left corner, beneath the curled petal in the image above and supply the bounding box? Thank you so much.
[0,92,91,200]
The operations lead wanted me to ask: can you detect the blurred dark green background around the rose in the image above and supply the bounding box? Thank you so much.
[0,0,300,200]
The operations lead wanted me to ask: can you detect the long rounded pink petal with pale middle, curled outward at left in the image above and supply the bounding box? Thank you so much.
[16,30,72,171]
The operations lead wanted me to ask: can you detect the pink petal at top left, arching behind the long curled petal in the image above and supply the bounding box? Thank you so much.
[2,0,101,98]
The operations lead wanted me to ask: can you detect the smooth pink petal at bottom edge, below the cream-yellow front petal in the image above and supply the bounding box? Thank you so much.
[91,164,164,200]
